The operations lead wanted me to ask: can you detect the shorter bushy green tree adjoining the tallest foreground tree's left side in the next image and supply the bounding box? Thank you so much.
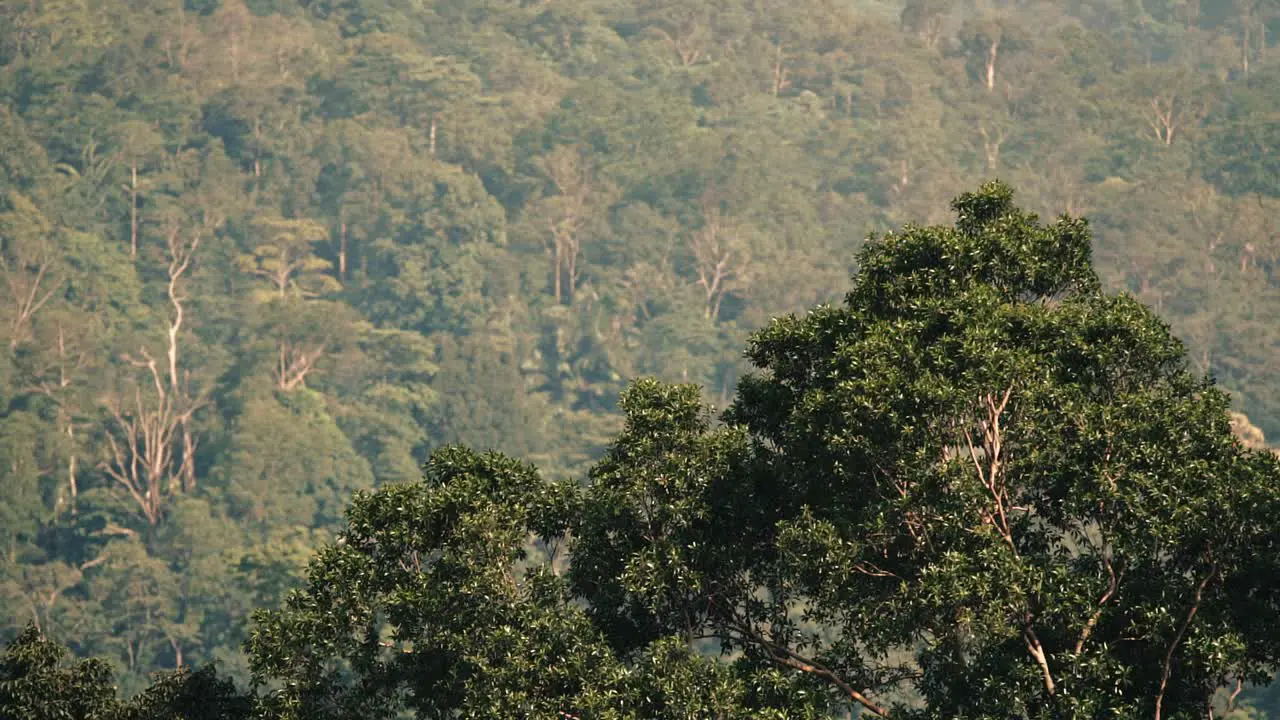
[248,447,820,720]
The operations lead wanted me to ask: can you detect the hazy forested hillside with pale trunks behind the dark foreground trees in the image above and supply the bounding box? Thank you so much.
[0,0,1280,719]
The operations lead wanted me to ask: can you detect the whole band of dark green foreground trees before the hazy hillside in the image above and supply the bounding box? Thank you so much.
[0,183,1280,720]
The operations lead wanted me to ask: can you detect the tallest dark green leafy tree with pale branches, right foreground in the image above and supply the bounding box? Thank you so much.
[571,183,1280,719]
